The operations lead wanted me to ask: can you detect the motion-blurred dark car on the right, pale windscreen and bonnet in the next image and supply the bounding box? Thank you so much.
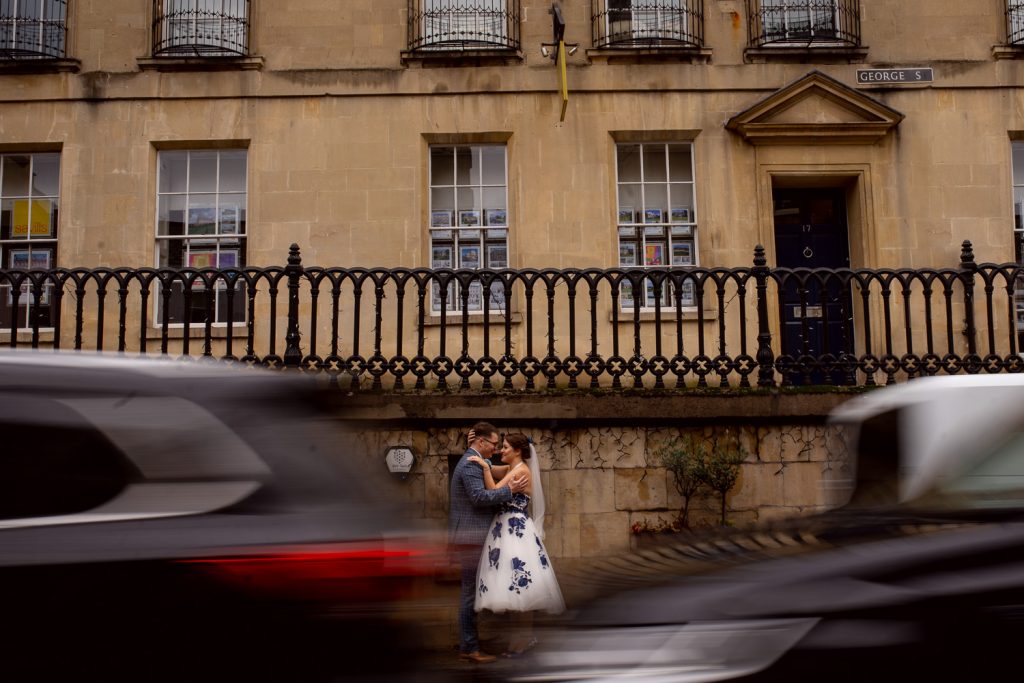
[520,376,1024,683]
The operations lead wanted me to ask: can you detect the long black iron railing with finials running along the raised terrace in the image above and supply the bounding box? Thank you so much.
[0,243,1024,391]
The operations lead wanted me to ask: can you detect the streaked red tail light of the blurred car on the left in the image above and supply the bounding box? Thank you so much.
[179,541,442,602]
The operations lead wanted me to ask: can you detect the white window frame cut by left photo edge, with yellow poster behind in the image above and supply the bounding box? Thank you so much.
[0,152,61,332]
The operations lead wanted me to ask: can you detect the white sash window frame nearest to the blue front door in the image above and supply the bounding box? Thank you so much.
[615,140,700,312]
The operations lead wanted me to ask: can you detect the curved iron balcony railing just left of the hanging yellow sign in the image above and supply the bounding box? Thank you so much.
[409,0,520,51]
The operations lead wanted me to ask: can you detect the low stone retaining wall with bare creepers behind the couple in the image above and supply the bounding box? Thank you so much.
[337,395,850,559]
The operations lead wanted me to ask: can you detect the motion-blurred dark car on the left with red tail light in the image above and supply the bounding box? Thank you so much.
[0,352,434,681]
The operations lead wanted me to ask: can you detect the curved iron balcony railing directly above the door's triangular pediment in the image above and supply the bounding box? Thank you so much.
[746,0,860,47]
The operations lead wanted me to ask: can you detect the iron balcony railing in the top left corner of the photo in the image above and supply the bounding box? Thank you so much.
[0,0,68,59]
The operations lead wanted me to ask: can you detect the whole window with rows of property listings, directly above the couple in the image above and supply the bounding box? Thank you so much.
[429,144,509,315]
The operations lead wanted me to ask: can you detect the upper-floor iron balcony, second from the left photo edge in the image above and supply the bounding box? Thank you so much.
[153,0,249,57]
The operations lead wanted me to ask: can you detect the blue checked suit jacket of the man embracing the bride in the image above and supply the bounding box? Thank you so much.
[449,449,512,546]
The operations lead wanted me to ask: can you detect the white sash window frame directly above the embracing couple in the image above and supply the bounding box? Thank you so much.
[427,142,512,316]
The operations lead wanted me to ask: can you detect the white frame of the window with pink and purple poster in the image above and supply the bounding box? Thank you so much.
[153,147,249,328]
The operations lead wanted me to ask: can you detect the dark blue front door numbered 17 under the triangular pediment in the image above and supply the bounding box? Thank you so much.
[772,187,853,384]
